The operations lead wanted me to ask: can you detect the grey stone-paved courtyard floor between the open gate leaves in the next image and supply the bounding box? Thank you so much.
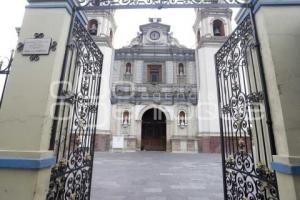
[92,152,223,200]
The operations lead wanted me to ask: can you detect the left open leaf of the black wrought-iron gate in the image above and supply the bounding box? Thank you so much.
[47,14,103,200]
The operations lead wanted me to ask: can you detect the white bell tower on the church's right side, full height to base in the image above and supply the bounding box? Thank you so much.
[193,8,232,152]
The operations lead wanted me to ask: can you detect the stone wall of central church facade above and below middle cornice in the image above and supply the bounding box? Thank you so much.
[109,54,198,152]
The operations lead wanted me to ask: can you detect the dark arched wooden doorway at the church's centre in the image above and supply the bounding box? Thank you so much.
[141,108,167,151]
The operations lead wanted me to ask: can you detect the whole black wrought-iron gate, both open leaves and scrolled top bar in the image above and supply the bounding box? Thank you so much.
[38,0,279,200]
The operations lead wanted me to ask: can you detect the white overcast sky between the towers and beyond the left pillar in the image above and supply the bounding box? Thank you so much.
[0,0,199,56]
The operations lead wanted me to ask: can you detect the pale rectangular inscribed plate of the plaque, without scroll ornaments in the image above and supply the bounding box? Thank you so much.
[22,38,51,55]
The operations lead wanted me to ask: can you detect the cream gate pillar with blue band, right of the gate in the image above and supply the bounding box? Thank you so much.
[255,0,300,200]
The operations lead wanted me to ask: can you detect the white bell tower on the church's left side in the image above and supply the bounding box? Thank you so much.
[86,10,117,151]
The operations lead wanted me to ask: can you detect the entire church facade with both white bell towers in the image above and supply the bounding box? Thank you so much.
[87,8,232,153]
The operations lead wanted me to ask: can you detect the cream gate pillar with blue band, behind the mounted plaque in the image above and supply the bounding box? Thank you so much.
[0,0,84,200]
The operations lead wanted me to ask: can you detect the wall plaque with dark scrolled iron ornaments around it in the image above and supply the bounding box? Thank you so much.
[17,33,57,61]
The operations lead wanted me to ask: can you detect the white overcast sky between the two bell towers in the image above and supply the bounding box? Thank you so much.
[114,9,195,48]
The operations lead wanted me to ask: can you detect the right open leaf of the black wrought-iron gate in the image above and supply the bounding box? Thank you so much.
[215,14,279,200]
